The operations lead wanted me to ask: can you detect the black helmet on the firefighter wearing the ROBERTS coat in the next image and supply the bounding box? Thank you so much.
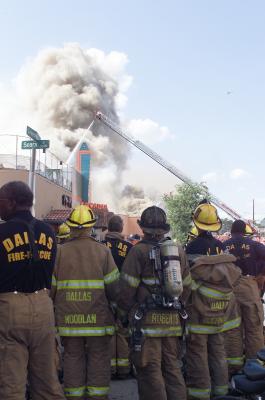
[137,206,170,235]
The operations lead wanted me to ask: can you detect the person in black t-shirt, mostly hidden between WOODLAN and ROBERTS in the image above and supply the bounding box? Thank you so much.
[103,215,132,379]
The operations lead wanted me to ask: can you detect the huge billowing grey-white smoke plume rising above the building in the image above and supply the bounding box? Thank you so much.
[0,43,170,213]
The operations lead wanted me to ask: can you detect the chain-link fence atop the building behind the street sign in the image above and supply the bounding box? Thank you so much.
[0,134,72,190]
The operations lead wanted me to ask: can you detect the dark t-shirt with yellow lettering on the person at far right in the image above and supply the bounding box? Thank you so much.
[224,234,265,276]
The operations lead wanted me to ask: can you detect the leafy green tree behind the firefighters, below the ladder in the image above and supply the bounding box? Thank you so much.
[164,183,210,244]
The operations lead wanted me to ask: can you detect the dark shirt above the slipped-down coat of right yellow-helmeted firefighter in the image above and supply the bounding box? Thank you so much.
[186,232,225,256]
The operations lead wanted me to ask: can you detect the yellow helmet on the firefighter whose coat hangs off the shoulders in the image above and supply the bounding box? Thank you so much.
[193,203,222,232]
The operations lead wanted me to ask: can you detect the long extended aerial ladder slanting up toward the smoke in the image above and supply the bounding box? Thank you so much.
[96,112,250,223]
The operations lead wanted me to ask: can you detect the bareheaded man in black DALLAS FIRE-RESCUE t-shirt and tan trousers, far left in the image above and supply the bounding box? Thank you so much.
[0,181,65,400]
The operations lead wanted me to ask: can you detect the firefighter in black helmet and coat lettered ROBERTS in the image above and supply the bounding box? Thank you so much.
[118,206,191,400]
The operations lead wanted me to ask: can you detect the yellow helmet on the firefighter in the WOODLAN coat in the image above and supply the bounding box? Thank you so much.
[66,205,97,229]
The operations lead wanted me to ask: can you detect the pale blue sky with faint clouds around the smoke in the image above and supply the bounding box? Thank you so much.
[0,0,265,219]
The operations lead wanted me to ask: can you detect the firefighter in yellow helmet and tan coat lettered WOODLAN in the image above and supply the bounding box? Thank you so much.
[51,205,119,400]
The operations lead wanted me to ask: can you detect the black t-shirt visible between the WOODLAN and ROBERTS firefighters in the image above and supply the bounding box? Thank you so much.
[103,232,133,270]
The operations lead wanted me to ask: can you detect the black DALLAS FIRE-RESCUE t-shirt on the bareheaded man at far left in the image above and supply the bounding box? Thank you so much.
[0,211,56,293]
